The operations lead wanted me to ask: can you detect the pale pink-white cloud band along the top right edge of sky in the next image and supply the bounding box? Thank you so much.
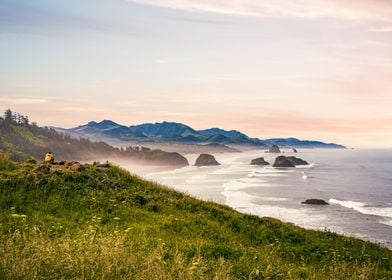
[128,0,392,22]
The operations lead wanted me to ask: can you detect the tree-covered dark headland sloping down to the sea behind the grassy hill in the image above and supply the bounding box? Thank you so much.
[0,110,188,165]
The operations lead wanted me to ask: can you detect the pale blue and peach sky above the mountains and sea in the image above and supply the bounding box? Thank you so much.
[0,0,392,148]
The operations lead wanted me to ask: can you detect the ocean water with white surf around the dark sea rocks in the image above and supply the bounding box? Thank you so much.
[136,149,392,248]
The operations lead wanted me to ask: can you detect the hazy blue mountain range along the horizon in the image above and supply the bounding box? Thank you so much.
[68,120,344,148]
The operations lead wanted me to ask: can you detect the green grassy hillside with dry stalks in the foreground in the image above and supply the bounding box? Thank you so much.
[0,157,392,279]
